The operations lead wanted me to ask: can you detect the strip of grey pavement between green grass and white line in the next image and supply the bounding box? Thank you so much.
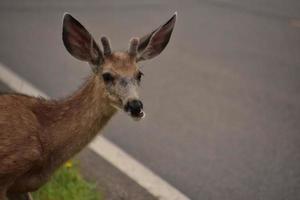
[76,148,159,200]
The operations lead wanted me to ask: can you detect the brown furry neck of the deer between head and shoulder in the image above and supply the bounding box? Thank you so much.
[41,75,116,168]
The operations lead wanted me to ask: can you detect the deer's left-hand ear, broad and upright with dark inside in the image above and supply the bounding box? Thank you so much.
[62,13,103,66]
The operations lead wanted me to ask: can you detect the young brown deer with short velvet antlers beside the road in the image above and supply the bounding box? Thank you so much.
[0,13,176,200]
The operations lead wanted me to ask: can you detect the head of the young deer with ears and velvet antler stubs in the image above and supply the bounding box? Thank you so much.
[62,13,177,119]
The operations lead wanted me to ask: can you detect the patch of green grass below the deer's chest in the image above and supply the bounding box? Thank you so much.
[33,162,104,200]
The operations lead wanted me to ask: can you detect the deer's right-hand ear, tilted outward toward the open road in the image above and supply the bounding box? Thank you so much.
[137,12,177,61]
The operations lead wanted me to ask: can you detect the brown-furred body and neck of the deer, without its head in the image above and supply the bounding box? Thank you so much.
[0,75,116,200]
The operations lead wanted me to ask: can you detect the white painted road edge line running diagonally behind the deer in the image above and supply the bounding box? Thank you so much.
[0,63,189,200]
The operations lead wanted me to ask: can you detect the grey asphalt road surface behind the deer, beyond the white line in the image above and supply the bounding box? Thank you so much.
[0,0,300,200]
